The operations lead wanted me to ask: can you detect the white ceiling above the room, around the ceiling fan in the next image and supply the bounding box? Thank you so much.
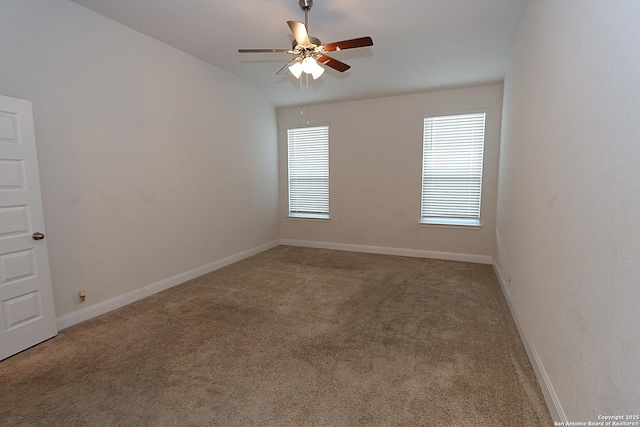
[72,0,529,107]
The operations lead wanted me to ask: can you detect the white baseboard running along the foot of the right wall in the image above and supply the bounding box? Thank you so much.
[492,261,569,425]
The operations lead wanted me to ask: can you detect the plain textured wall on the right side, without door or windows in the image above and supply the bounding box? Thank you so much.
[496,0,640,422]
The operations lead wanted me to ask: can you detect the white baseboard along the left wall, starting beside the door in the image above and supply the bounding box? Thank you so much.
[56,240,280,331]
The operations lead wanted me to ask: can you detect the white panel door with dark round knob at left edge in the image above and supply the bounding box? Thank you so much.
[0,96,58,360]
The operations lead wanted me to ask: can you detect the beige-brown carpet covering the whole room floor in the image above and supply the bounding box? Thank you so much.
[0,246,553,427]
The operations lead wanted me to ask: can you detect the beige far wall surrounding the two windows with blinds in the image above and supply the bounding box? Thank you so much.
[278,84,502,259]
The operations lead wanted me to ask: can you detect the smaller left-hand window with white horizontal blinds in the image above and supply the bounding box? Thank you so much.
[287,126,329,219]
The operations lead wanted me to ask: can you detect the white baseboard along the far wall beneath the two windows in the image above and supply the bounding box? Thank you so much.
[280,239,493,265]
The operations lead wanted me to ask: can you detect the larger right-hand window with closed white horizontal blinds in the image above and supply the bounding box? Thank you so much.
[420,112,486,226]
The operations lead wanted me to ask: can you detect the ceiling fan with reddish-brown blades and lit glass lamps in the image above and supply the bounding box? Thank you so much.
[238,0,373,80]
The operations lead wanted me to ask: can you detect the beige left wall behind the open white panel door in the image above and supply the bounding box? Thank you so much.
[0,0,278,320]
